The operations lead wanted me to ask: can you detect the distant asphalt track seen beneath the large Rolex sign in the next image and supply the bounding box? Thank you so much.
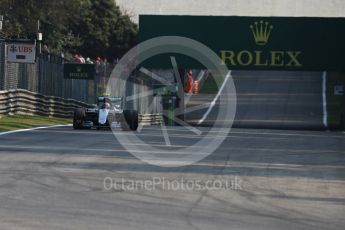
[186,71,325,130]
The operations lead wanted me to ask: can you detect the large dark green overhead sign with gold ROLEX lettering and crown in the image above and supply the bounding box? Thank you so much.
[139,15,345,71]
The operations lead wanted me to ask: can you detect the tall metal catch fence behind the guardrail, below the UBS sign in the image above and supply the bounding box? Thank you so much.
[0,42,91,102]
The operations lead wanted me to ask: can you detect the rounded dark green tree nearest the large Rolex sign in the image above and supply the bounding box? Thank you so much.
[75,0,137,58]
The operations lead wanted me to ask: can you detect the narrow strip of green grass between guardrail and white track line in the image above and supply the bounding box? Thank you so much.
[0,115,72,132]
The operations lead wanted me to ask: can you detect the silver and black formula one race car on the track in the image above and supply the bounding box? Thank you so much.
[73,96,138,131]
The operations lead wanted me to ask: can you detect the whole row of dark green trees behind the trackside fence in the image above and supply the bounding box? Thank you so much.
[0,0,137,58]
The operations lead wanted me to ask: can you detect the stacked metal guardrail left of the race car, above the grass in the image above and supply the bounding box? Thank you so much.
[0,89,90,118]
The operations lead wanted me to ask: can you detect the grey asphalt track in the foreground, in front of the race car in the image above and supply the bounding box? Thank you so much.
[0,126,345,230]
